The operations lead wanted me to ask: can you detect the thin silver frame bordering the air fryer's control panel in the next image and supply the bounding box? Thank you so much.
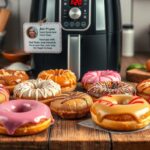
[59,0,92,31]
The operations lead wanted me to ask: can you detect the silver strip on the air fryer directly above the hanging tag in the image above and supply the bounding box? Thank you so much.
[46,0,56,22]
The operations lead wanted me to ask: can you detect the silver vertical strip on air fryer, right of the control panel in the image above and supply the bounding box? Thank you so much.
[96,0,106,31]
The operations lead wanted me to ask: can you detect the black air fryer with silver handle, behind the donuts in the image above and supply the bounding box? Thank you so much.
[30,0,122,79]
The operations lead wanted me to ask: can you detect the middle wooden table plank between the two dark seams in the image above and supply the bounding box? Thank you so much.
[49,120,110,150]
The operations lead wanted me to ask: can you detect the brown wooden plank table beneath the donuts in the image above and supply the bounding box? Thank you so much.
[0,54,150,150]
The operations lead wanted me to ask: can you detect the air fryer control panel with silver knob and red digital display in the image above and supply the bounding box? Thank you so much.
[60,0,91,31]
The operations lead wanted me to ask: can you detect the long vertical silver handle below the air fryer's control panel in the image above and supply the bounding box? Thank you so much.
[68,34,81,79]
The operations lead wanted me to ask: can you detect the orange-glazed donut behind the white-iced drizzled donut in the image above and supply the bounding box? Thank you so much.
[38,69,77,92]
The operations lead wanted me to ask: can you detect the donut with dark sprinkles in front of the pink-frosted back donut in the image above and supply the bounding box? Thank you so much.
[87,82,136,101]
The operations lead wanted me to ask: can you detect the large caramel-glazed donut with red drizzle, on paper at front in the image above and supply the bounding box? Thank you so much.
[90,94,150,131]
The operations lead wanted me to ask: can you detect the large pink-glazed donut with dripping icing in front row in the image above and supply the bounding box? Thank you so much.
[0,100,54,136]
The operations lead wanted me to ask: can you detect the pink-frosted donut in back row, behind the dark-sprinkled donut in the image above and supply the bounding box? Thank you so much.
[81,70,121,89]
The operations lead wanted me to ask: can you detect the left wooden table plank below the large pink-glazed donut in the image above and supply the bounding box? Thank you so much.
[0,130,49,150]
